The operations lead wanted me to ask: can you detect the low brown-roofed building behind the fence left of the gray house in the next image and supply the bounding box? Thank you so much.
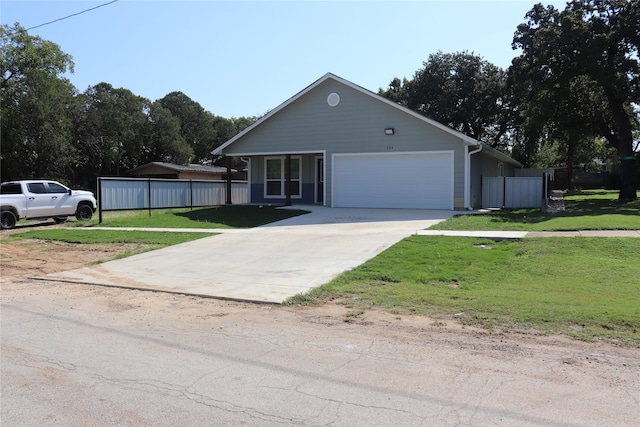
[128,162,237,181]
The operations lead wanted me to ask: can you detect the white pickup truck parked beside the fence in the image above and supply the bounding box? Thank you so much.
[0,180,98,229]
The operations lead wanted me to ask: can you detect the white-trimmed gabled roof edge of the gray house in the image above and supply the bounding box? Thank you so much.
[211,73,522,167]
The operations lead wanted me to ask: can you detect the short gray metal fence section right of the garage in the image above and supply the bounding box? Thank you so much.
[482,175,549,209]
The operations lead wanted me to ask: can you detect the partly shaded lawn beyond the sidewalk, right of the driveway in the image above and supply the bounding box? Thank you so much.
[431,190,640,231]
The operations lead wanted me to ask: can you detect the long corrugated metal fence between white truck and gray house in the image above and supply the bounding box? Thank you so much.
[98,177,249,222]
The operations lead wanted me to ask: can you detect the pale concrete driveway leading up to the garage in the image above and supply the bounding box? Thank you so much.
[39,206,455,303]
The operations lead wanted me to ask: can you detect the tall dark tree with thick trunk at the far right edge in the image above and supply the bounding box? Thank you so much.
[513,0,640,201]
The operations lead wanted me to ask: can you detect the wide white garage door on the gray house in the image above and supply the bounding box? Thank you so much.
[332,151,453,209]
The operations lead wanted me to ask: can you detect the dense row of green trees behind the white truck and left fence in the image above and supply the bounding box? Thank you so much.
[0,24,255,187]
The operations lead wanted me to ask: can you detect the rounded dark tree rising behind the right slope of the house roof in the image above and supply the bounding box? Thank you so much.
[378,52,509,147]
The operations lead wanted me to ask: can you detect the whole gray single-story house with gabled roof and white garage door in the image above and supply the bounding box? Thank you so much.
[213,73,522,209]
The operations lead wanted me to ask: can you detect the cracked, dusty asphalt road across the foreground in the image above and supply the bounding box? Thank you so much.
[1,280,640,426]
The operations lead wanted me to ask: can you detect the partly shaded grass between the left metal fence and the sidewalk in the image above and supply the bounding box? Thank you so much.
[70,205,307,228]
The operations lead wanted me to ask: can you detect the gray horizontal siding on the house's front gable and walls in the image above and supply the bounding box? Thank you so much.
[224,80,465,208]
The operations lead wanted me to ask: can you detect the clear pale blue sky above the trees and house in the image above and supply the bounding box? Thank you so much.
[0,0,566,118]
